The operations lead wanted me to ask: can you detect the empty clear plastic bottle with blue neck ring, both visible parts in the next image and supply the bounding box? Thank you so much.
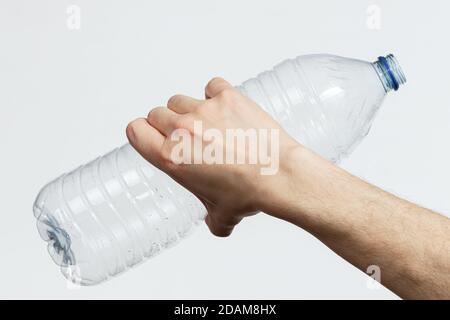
[33,54,406,285]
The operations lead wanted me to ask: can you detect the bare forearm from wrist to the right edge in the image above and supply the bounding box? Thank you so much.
[256,148,450,298]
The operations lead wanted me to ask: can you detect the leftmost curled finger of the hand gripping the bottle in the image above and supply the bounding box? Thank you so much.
[126,118,165,167]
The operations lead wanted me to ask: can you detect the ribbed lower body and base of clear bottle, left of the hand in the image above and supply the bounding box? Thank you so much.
[34,144,206,284]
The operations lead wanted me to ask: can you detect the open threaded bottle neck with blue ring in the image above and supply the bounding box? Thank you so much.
[372,54,406,92]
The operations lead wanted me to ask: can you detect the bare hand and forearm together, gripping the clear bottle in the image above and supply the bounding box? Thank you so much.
[127,78,450,299]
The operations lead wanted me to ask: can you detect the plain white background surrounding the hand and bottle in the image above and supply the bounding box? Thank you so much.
[0,0,450,299]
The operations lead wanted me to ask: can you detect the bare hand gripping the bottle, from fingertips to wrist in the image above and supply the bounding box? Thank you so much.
[127,78,300,236]
